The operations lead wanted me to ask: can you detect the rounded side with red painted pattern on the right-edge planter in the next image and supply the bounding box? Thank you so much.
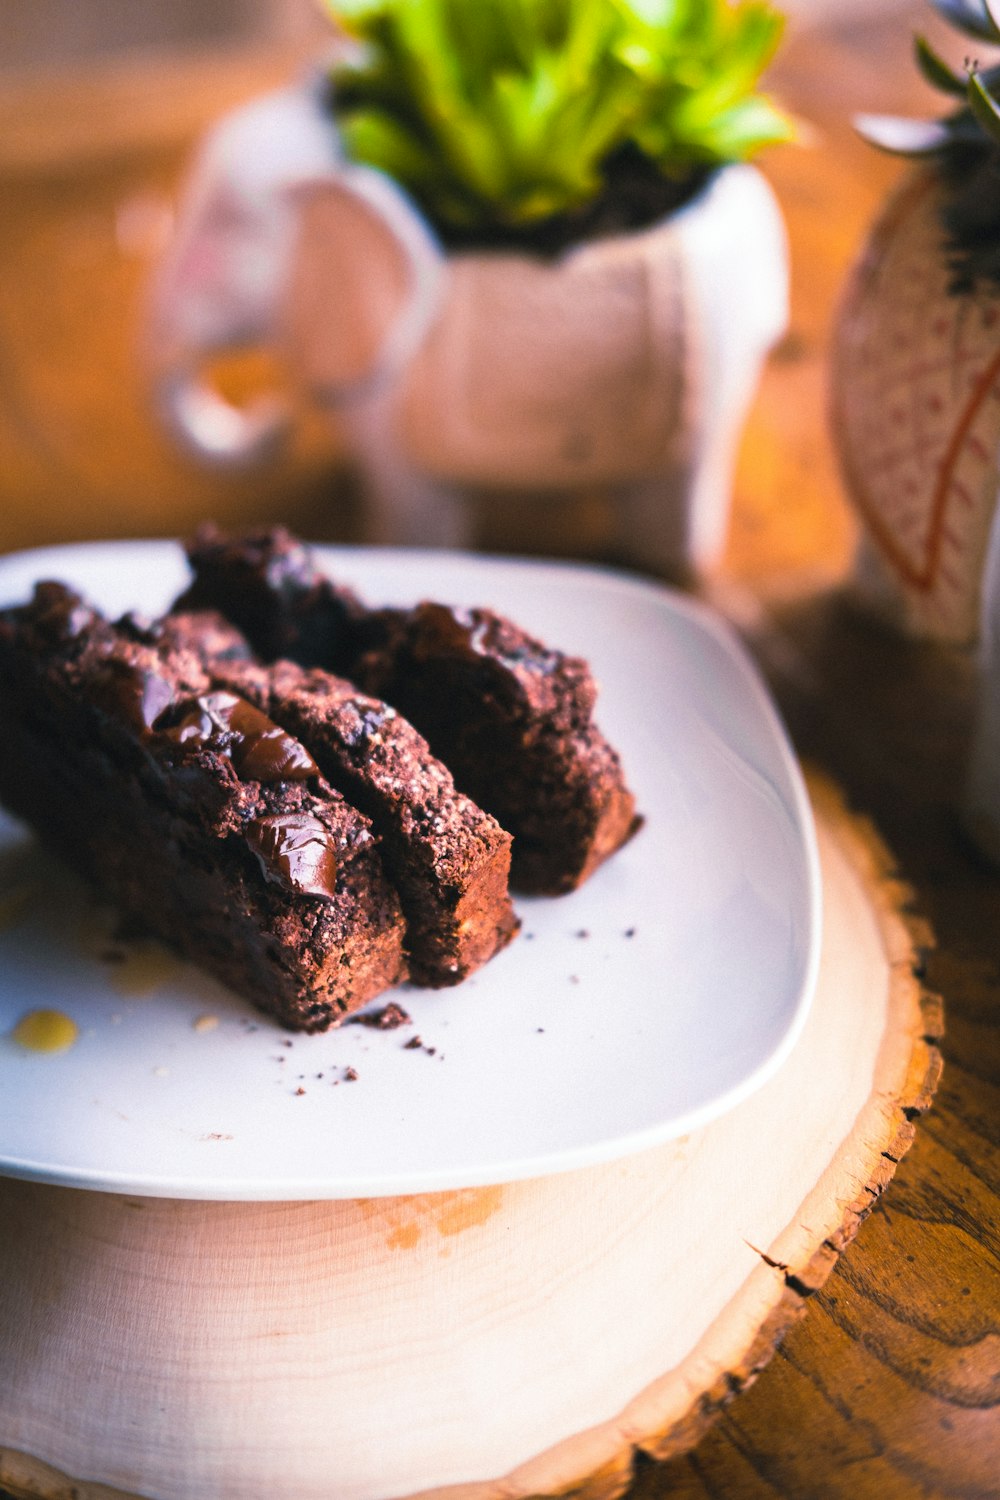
[832,173,1000,636]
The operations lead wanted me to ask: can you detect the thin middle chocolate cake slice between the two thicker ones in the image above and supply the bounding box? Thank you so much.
[159,614,519,989]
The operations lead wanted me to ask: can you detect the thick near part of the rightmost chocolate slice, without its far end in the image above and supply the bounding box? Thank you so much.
[354,603,640,896]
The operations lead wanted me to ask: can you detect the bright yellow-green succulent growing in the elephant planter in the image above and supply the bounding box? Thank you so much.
[327,0,792,249]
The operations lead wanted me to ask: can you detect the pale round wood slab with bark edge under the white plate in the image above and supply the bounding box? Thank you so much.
[0,779,942,1500]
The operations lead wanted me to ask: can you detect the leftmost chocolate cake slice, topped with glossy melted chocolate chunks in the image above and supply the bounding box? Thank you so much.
[0,584,406,1031]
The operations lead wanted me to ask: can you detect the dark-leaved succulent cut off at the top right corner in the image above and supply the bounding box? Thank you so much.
[855,0,1000,294]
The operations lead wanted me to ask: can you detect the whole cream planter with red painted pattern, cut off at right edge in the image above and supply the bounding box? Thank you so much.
[834,168,1000,858]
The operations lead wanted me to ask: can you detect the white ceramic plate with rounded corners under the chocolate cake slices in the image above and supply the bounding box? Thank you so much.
[0,543,820,1200]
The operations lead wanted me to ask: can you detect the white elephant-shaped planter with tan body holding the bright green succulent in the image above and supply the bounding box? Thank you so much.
[150,77,787,572]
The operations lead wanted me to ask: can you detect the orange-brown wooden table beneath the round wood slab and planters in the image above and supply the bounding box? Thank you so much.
[0,11,1000,1500]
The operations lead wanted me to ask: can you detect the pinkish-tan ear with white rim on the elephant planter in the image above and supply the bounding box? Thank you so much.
[285,167,444,402]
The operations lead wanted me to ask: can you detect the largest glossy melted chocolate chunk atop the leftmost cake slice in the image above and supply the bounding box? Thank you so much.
[162,693,319,782]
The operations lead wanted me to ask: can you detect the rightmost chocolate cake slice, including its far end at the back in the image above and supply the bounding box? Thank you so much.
[175,527,640,896]
